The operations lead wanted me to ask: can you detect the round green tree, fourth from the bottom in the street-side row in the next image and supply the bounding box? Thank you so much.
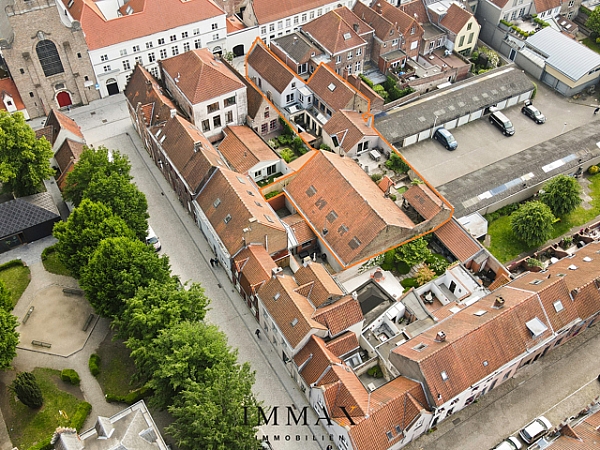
[80,237,171,318]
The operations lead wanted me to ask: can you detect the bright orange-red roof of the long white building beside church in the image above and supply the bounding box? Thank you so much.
[63,0,225,50]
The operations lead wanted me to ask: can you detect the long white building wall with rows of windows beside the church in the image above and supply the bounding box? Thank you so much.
[83,13,227,97]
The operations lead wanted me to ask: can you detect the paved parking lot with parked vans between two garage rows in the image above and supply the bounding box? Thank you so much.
[399,80,600,187]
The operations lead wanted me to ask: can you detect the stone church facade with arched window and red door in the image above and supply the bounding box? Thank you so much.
[0,0,100,118]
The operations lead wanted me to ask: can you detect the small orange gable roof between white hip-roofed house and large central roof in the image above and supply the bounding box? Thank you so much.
[219,125,279,174]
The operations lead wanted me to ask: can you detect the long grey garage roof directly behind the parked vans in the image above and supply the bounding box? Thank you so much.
[375,65,534,145]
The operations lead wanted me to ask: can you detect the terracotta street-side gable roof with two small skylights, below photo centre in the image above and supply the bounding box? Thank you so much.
[258,275,326,348]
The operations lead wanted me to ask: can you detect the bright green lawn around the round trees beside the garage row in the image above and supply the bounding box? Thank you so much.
[488,174,600,263]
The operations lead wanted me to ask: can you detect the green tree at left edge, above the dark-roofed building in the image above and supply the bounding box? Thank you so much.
[0,111,54,197]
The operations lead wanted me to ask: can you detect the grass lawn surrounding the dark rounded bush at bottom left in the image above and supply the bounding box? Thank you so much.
[6,367,83,449]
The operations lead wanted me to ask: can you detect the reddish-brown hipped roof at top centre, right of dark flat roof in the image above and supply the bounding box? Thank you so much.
[302,6,366,55]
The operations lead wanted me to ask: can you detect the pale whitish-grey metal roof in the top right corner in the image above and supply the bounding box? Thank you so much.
[525,27,600,81]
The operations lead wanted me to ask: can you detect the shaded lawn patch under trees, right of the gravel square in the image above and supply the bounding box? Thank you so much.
[96,333,141,396]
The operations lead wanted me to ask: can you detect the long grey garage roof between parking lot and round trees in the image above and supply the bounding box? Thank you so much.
[437,124,600,218]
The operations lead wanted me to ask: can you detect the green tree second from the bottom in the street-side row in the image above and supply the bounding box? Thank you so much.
[131,321,237,408]
